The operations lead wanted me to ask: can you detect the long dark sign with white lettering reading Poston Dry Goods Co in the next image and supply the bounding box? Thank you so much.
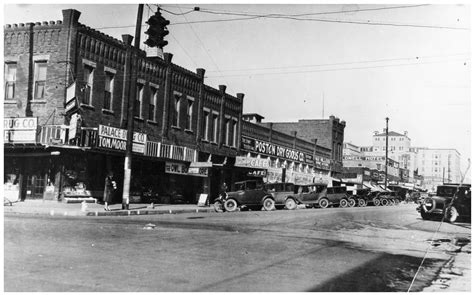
[242,136,306,162]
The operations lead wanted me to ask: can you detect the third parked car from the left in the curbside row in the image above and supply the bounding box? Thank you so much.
[285,184,327,210]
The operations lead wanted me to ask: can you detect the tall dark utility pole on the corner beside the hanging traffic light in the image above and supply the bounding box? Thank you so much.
[122,4,143,210]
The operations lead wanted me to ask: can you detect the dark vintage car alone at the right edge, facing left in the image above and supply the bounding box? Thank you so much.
[417,184,471,223]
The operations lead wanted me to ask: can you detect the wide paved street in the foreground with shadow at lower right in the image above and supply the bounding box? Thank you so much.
[4,204,470,292]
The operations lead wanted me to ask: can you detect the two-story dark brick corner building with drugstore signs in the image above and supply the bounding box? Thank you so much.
[4,10,244,202]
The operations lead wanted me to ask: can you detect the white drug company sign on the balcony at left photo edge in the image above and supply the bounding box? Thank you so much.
[3,117,38,143]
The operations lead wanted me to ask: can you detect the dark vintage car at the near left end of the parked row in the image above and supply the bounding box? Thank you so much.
[224,180,275,212]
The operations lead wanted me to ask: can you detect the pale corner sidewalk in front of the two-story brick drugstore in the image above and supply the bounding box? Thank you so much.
[3,200,214,216]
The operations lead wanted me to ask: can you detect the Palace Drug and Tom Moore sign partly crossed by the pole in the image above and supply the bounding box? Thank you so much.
[97,125,146,154]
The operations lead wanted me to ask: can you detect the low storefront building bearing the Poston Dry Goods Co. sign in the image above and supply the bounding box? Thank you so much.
[236,114,332,184]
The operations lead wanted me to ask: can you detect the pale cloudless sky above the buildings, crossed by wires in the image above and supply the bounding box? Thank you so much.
[4,1,471,175]
